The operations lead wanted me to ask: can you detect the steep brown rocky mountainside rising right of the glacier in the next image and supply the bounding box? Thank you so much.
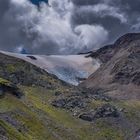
[82,34,140,99]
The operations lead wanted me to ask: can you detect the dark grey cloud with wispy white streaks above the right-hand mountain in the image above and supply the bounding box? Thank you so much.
[72,0,140,42]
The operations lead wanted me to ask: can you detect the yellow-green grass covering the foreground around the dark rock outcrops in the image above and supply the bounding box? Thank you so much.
[0,86,140,140]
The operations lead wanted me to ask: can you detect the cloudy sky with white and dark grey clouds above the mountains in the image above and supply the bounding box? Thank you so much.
[0,0,140,54]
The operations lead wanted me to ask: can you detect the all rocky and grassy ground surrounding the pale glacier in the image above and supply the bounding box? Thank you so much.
[0,34,140,140]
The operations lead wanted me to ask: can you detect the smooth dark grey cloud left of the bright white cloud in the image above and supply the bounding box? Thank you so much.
[0,0,33,51]
